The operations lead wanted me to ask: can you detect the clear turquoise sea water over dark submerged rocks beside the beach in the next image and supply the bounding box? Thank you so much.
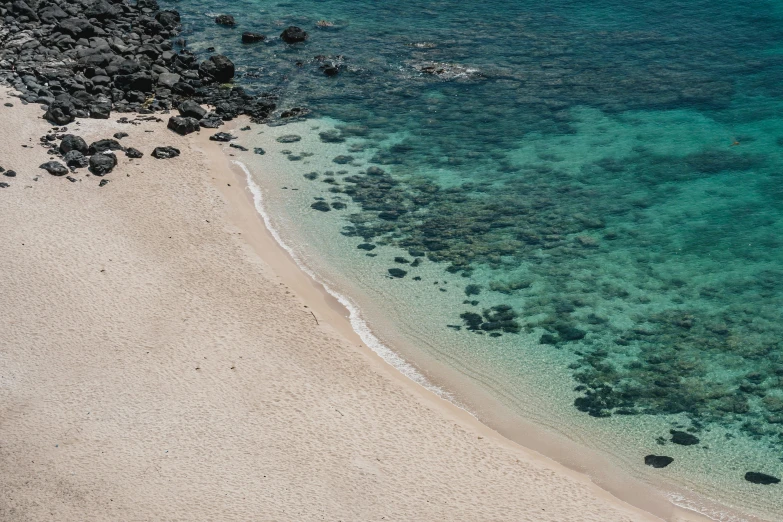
[168,0,783,518]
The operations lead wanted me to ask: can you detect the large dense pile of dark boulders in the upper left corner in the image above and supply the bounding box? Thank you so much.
[0,0,275,128]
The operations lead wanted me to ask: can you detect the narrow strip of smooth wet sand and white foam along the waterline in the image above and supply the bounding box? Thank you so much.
[198,117,728,522]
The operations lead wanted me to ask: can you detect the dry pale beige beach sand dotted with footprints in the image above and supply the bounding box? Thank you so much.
[0,91,700,521]
